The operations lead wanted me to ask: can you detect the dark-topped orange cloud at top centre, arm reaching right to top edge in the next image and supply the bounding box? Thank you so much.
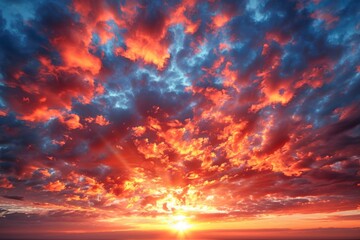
[119,0,200,70]
